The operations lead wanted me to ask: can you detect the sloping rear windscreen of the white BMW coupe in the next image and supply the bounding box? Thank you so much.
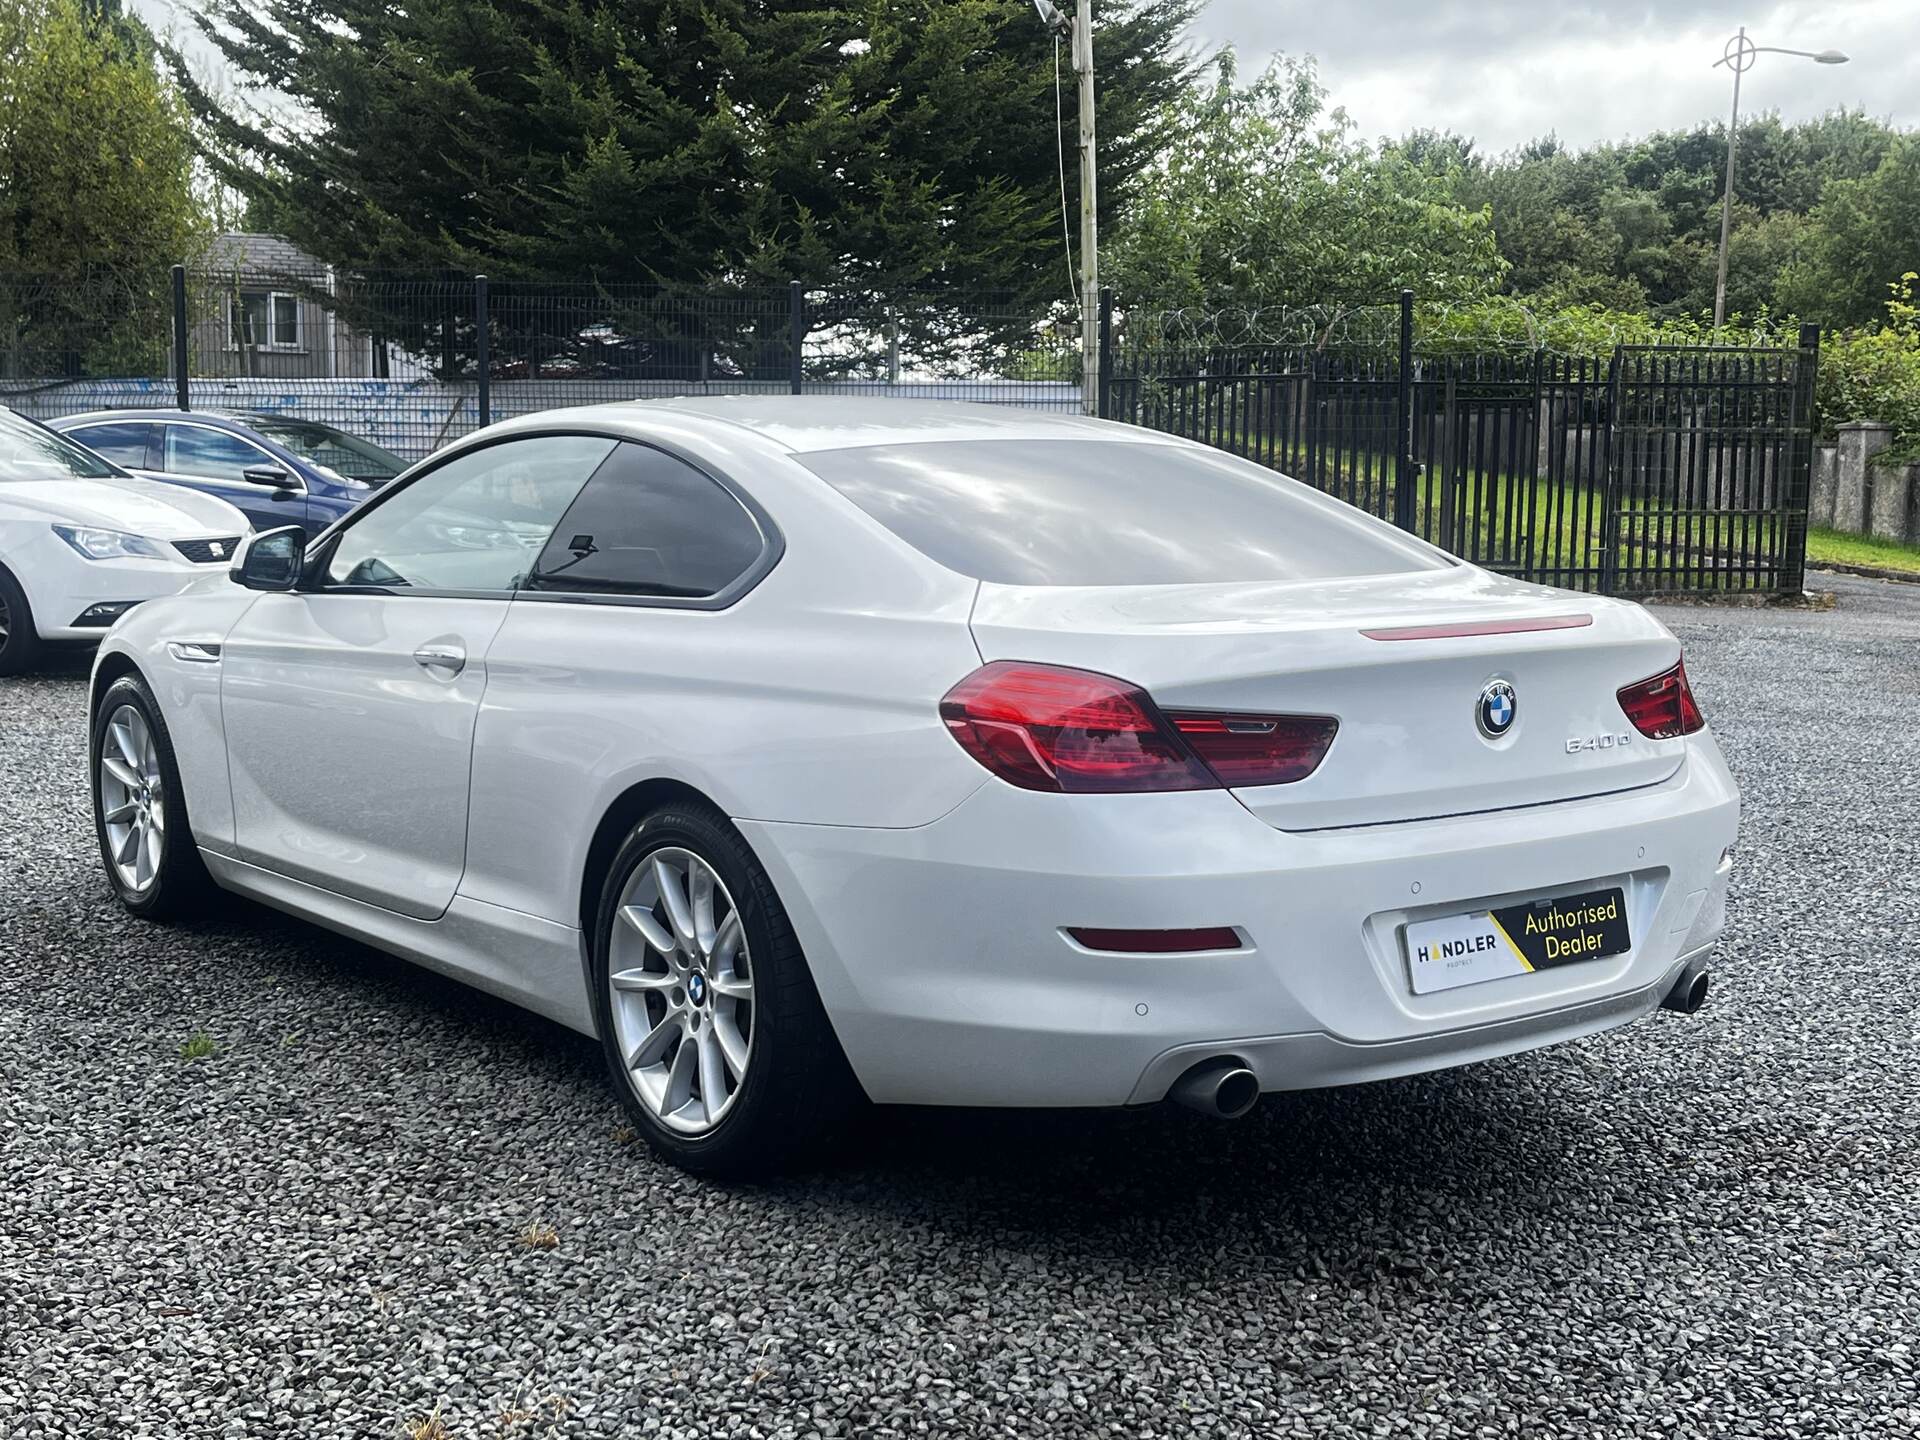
[795,440,1450,586]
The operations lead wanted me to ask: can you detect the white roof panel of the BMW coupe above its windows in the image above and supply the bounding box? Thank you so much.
[610,396,1179,453]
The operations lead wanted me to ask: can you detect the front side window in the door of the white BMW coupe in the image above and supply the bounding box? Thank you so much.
[324,436,616,591]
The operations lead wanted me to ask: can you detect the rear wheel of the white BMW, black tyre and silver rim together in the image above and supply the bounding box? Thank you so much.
[593,803,858,1179]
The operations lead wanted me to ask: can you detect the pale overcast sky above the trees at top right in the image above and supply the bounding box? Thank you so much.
[1198,0,1920,152]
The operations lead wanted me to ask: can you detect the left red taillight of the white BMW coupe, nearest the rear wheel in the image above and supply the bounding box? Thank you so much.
[941,660,1338,795]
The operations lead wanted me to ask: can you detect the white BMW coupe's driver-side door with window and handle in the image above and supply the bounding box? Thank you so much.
[221,434,614,920]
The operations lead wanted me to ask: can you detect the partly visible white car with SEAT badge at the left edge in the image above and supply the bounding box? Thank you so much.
[0,409,248,676]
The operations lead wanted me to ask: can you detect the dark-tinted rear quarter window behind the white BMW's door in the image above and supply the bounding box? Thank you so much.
[526,444,766,599]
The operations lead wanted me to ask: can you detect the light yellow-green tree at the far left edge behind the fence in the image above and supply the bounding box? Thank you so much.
[0,0,204,374]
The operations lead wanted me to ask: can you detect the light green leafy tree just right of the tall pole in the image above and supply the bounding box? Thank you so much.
[1106,52,1503,305]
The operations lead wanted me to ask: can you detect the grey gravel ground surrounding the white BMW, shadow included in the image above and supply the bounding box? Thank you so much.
[0,580,1920,1440]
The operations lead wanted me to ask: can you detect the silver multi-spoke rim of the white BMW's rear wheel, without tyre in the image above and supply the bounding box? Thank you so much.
[607,847,755,1135]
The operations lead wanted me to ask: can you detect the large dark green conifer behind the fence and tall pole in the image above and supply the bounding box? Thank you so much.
[182,0,1196,296]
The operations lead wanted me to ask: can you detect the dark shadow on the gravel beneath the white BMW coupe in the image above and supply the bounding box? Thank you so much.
[139,902,1661,1275]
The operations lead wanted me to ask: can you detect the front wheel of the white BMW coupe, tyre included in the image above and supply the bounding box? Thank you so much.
[90,676,213,920]
